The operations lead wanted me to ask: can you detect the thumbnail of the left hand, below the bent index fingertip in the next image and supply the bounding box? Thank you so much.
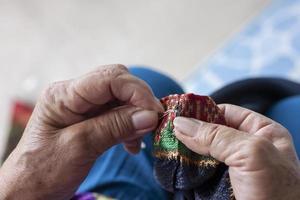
[132,110,158,131]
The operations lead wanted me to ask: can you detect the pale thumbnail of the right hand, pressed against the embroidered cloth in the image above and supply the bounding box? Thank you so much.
[173,117,200,136]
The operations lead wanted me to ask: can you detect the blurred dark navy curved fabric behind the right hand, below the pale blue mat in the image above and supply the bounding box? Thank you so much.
[210,78,300,114]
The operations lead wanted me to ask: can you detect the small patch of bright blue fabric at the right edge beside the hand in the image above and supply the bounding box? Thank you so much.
[266,95,300,157]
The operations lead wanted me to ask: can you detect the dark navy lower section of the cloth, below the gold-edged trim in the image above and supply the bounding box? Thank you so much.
[154,158,232,200]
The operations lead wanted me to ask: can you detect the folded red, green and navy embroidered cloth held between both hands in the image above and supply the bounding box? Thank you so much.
[153,94,234,200]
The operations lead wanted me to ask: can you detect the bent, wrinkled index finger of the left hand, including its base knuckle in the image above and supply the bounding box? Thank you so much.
[37,64,163,126]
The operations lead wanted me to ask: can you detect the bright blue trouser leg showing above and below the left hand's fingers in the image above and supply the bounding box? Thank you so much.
[78,67,183,200]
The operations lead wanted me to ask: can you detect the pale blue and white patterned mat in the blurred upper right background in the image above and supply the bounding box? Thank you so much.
[184,0,300,94]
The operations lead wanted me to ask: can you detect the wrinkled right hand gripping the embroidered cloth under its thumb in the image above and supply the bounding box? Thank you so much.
[174,105,300,200]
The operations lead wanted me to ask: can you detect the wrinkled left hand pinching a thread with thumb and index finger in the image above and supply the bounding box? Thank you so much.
[0,65,163,200]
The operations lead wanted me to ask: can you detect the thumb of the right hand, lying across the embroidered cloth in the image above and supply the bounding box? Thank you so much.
[174,117,274,166]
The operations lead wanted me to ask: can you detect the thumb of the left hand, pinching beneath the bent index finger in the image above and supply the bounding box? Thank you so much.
[63,106,158,156]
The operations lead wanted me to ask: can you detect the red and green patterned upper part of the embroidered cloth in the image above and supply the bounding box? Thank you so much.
[153,94,225,166]
